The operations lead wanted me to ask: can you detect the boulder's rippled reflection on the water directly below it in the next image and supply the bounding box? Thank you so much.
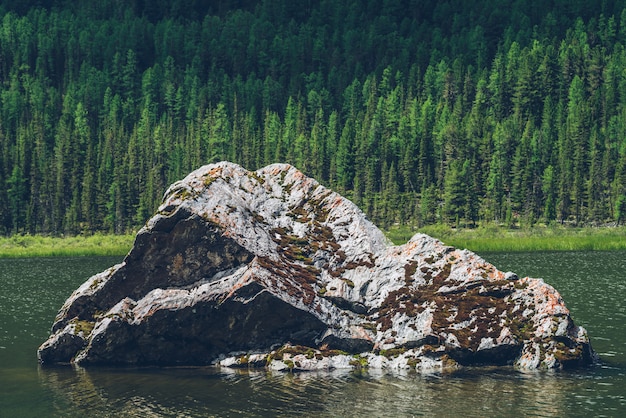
[39,368,582,417]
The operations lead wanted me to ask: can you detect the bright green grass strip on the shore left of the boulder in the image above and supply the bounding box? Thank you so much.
[0,234,135,258]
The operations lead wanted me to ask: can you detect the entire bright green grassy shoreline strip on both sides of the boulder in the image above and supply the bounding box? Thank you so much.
[0,225,626,258]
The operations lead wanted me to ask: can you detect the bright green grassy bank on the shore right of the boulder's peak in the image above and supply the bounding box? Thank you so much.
[387,225,626,252]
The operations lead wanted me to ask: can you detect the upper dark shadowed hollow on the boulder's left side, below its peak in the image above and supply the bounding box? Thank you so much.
[53,209,254,331]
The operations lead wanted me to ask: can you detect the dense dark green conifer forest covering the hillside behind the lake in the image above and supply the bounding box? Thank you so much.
[0,0,626,234]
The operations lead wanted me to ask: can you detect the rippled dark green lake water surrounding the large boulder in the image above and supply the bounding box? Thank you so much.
[0,252,626,418]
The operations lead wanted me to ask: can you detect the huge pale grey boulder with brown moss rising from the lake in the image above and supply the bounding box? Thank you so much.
[38,162,595,370]
